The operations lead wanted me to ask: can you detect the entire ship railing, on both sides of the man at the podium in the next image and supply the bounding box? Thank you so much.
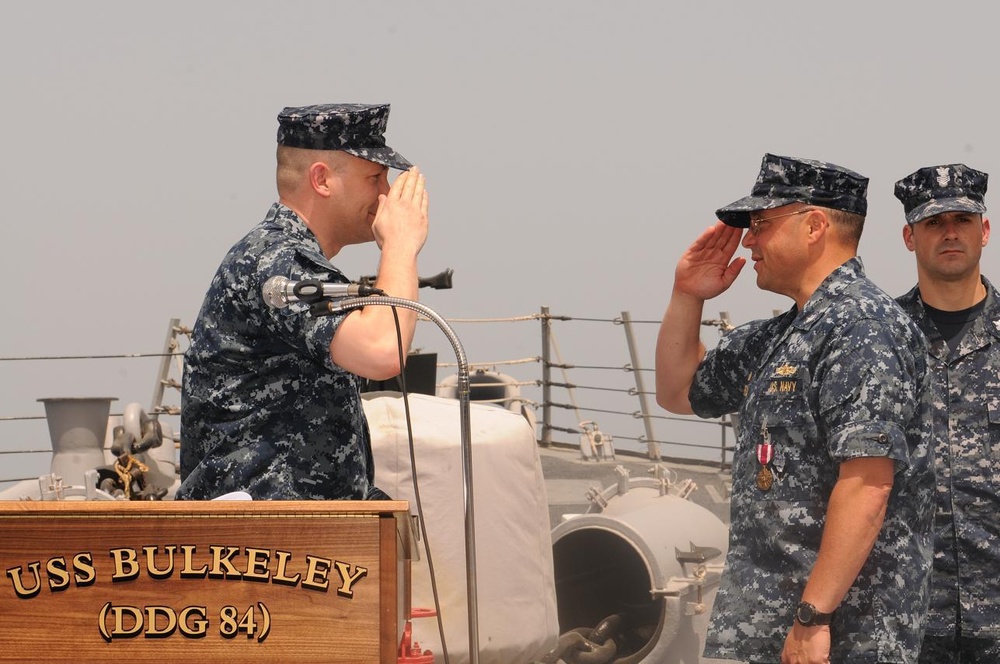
[0,307,734,488]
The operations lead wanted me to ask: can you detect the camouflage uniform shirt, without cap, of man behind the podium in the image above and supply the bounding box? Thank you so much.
[177,203,374,499]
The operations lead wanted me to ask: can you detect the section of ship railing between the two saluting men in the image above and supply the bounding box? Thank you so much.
[430,307,735,471]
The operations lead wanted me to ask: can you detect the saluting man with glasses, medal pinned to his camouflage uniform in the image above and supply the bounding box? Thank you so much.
[656,154,934,664]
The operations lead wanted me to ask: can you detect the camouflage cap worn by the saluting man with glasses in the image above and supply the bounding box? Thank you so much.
[715,154,868,228]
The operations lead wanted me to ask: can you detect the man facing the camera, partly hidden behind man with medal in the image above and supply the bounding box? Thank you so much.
[895,164,1000,664]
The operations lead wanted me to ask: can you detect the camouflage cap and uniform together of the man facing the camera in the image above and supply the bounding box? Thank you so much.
[894,164,1000,664]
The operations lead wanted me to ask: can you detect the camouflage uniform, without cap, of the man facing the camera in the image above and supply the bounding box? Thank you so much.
[899,278,1000,662]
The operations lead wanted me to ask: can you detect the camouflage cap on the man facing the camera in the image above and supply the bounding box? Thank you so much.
[895,164,989,224]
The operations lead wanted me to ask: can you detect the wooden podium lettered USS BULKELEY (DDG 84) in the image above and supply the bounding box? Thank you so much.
[0,501,411,664]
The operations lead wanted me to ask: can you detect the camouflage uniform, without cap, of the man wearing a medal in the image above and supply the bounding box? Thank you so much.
[689,258,934,664]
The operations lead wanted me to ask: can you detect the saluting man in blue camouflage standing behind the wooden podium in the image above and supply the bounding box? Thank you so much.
[177,104,428,500]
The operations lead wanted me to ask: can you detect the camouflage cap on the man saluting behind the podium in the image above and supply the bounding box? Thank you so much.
[278,104,412,171]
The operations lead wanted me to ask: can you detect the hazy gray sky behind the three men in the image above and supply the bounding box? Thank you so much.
[0,0,1000,462]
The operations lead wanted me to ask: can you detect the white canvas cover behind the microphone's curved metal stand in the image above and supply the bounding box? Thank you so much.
[364,392,559,664]
